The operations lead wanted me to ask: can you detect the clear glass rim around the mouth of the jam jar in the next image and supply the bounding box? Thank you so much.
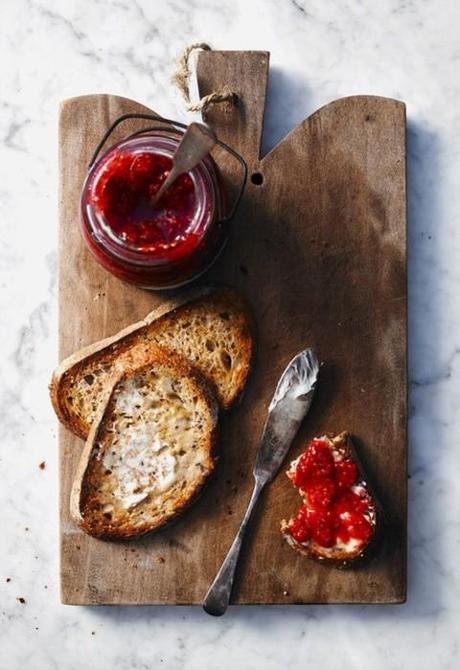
[80,130,217,265]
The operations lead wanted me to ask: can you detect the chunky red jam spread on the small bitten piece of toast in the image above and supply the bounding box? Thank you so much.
[289,440,373,548]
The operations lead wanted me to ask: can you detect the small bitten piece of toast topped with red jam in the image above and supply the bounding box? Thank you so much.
[281,432,382,567]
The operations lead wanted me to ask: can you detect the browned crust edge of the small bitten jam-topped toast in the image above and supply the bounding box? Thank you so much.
[280,431,384,568]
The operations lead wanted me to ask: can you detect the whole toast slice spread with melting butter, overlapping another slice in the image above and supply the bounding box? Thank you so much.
[71,349,218,539]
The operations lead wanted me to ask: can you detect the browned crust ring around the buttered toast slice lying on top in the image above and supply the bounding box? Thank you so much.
[70,347,219,540]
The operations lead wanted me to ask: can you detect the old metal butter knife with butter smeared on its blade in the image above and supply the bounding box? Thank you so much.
[203,349,319,616]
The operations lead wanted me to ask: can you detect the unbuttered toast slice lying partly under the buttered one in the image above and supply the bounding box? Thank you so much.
[50,288,253,439]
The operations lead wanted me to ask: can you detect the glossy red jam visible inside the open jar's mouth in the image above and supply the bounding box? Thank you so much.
[92,152,199,259]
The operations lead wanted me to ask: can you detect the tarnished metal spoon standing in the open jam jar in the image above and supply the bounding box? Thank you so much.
[150,123,217,207]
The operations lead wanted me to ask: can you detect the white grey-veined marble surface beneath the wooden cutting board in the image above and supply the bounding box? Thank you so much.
[0,0,460,670]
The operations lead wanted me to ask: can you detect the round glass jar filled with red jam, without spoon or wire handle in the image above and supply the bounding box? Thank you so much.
[80,133,226,289]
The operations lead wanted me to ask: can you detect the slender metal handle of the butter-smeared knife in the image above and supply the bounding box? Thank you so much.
[203,479,264,616]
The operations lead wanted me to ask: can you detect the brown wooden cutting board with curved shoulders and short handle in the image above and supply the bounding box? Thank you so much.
[59,52,407,604]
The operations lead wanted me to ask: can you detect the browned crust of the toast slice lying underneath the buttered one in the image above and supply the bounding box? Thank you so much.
[49,286,255,439]
